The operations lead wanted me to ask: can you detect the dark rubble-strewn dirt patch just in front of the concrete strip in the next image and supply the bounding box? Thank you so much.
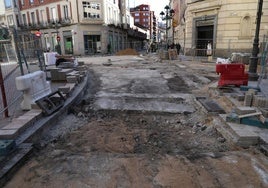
[52,111,228,158]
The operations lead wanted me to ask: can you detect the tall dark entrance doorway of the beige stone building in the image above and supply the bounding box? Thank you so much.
[196,25,213,56]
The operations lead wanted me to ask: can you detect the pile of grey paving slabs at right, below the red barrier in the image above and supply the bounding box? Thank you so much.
[215,87,268,150]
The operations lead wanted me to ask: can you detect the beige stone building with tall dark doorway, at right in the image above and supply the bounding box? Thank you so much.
[170,0,268,57]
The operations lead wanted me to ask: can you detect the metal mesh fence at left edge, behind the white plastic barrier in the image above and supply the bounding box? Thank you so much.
[0,30,39,119]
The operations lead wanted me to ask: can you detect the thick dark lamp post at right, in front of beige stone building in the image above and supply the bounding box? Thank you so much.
[248,0,263,81]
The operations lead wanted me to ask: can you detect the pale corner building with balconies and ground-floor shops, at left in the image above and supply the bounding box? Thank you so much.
[2,0,146,55]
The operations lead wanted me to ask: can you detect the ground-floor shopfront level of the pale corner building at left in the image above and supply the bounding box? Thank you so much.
[37,25,145,55]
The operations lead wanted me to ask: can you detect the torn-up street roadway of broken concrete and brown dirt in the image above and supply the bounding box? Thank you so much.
[5,55,268,188]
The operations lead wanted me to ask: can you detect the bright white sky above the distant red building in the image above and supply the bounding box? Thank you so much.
[129,0,169,17]
